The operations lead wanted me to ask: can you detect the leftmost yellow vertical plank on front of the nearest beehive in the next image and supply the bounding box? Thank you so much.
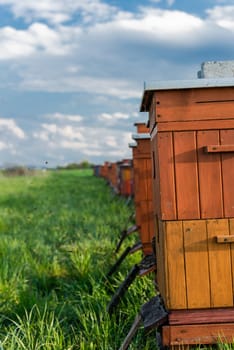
[165,221,188,309]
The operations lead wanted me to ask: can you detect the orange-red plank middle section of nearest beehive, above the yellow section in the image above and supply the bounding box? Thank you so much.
[152,129,234,220]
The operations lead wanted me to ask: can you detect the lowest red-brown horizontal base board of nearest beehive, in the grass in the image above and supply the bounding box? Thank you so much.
[163,323,234,346]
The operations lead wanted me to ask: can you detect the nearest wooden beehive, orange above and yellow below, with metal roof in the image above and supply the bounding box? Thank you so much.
[141,79,234,345]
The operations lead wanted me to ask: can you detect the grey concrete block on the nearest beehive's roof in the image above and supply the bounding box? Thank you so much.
[197,61,234,79]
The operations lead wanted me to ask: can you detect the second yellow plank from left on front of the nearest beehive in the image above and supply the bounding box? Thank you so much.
[183,220,210,309]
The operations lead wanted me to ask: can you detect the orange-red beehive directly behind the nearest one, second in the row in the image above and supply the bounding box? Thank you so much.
[133,133,154,255]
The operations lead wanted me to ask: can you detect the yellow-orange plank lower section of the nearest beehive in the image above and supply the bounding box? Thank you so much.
[156,219,234,310]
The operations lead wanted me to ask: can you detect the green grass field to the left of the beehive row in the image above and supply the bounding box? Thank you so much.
[0,170,156,350]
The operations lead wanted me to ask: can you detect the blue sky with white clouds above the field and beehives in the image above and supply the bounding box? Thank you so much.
[0,0,234,166]
